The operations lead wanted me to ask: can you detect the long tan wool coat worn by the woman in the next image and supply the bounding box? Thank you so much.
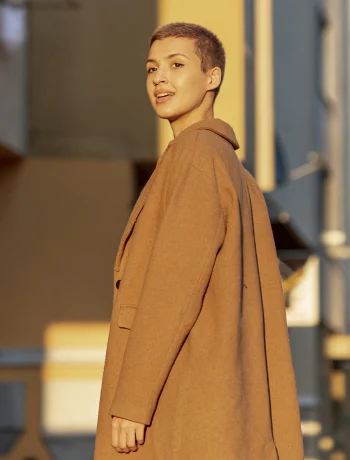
[94,119,303,460]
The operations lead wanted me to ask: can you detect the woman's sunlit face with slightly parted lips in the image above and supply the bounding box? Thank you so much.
[146,37,212,122]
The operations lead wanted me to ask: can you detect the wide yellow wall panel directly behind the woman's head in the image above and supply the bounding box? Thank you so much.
[158,0,245,159]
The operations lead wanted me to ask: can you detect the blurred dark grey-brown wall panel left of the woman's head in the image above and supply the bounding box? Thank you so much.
[28,0,157,159]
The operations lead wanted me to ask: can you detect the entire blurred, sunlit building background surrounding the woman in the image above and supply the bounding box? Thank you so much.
[0,0,350,460]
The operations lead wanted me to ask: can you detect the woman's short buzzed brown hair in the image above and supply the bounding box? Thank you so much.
[150,22,226,98]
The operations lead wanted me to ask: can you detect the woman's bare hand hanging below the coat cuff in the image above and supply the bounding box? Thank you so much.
[112,416,145,454]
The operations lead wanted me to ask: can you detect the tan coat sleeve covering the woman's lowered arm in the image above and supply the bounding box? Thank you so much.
[109,160,225,425]
